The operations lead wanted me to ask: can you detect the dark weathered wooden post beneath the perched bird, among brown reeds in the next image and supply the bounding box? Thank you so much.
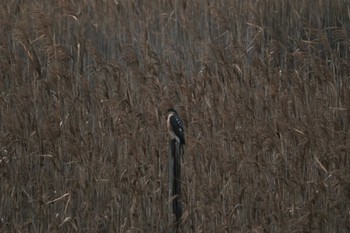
[169,140,183,232]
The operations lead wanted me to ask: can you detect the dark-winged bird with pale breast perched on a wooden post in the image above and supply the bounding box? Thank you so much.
[167,108,186,145]
